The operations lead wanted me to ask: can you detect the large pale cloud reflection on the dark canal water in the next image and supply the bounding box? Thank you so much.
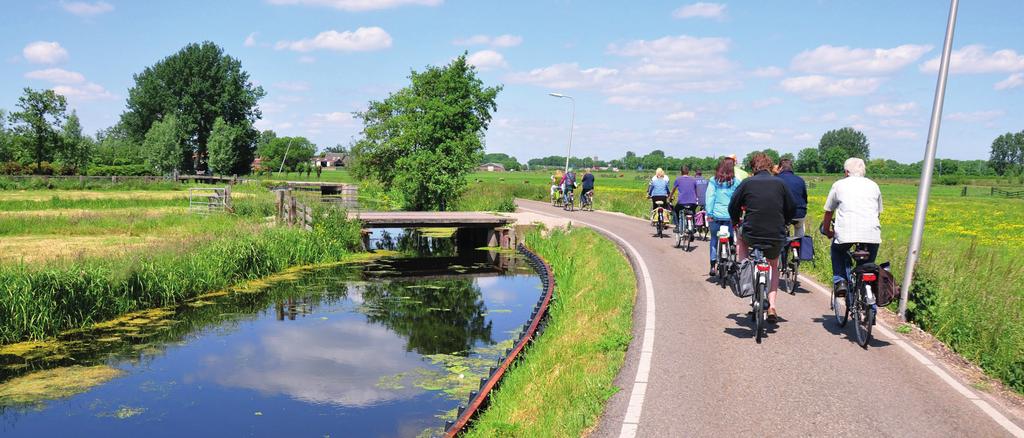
[202,320,422,407]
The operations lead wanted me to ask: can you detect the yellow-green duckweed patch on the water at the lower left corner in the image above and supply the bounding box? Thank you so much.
[0,365,124,404]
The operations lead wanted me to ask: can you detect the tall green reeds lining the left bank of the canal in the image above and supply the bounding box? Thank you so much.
[0,212,359,344]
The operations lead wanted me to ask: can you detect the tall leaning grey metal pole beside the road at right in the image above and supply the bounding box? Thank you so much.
[899,0,959,320]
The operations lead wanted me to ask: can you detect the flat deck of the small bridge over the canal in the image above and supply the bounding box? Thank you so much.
[348,212,515,228]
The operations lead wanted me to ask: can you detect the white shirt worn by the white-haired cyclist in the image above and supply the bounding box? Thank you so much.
[825,176,882,244]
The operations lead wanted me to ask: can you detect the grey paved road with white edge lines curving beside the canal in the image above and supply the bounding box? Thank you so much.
[519,201,1024,437]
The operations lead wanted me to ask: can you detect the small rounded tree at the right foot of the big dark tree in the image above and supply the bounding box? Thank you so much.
[207,117,256,175]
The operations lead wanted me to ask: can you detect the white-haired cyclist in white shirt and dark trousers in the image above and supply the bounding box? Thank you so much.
[820,158,882,297]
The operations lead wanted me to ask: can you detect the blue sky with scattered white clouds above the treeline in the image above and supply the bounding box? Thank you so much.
[0,0,1024,162]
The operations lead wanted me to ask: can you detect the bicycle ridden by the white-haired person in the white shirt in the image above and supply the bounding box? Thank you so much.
[831,244,881,350]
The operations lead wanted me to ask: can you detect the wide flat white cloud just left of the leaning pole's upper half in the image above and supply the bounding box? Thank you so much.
[792,44,932,76]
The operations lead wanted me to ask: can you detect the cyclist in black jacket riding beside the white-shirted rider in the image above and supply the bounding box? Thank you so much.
[729,154,797,321]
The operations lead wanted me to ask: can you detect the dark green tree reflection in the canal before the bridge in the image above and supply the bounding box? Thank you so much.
[362,279,494,354]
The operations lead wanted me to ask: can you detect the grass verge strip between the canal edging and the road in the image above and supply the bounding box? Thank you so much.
[469,228,636,437]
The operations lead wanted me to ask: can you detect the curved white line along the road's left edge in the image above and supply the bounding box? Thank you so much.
[519,207,655,438]
